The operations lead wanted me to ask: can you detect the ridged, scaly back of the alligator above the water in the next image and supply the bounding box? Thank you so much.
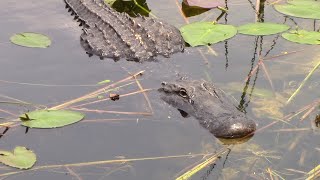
[64,0,185,62]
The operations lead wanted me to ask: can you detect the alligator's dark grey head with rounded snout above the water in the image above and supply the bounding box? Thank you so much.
[158,78,256,139]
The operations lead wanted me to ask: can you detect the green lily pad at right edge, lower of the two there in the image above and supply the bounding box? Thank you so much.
[282,30,320,44]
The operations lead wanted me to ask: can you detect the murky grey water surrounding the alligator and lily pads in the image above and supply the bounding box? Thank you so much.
[0,0,320,180]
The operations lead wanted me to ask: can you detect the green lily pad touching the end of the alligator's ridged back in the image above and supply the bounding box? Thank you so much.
[180,22,237,47]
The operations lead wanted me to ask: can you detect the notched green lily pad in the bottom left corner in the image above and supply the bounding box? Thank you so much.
[0,146,37,169]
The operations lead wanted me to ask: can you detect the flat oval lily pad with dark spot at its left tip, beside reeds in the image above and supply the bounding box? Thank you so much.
[20,110,84,128]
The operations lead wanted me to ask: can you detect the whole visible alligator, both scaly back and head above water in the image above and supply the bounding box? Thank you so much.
[64,0,256,139]
